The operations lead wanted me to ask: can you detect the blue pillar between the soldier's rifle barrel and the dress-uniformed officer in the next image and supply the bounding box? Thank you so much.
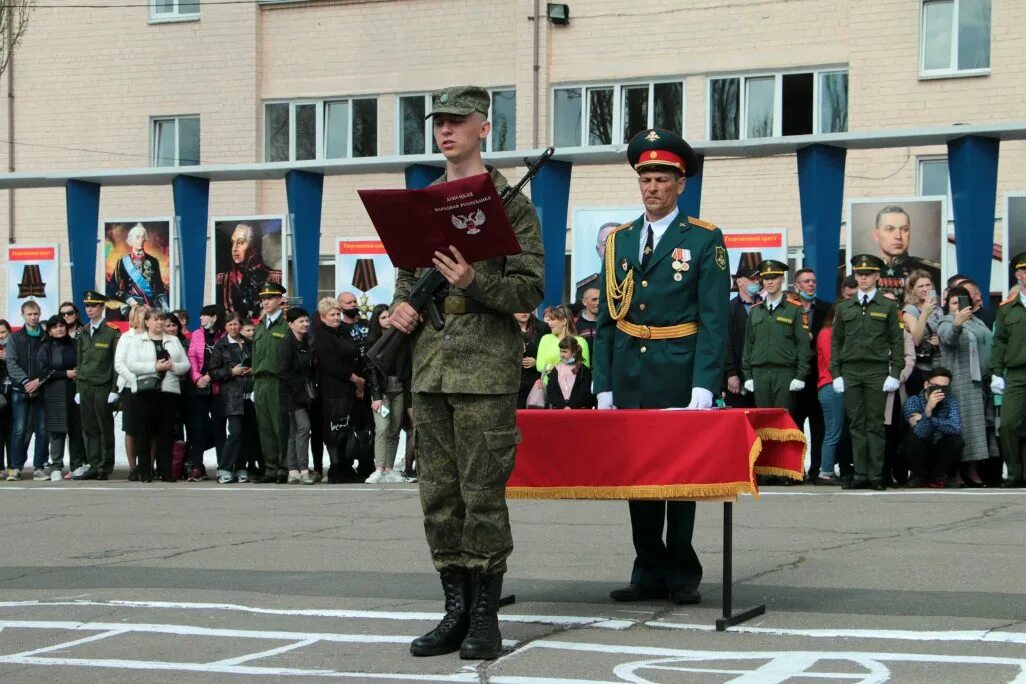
[530,160,574,308]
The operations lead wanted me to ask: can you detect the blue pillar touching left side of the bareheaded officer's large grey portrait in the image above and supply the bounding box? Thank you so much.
[798,144,846,301]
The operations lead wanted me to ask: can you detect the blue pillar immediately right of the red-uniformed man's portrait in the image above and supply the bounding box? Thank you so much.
[285,171,324,312]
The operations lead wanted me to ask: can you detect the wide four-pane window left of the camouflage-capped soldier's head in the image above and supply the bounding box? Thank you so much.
[264,97,378,161]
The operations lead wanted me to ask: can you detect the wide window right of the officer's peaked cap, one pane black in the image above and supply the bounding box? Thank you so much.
[708,70,847,140]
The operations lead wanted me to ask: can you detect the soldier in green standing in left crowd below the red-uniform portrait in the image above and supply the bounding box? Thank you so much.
[252,282,291,484]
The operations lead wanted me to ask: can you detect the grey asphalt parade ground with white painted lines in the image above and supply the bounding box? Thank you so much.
[0,473,1026,684]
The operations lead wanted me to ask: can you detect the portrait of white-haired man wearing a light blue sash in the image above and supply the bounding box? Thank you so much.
[103,218,172,320]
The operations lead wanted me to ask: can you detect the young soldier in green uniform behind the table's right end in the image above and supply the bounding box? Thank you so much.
[741,259,812,412]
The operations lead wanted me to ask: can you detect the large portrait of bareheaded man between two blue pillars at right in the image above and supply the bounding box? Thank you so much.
[845,197,947,304]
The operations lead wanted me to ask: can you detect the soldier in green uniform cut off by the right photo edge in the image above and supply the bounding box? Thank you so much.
[990,252,1026,488]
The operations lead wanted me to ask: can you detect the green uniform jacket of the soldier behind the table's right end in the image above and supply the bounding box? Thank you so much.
[741,296,812,380]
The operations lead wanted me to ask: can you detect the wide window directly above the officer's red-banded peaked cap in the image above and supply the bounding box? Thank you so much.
[552,81,684,147]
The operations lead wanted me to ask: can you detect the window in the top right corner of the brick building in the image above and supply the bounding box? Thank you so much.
[919,0,991,76]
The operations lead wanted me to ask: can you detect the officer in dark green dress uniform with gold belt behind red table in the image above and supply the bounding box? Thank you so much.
[592,129,731,604]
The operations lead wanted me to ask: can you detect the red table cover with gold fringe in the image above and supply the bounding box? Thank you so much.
[506,408,805,499]
